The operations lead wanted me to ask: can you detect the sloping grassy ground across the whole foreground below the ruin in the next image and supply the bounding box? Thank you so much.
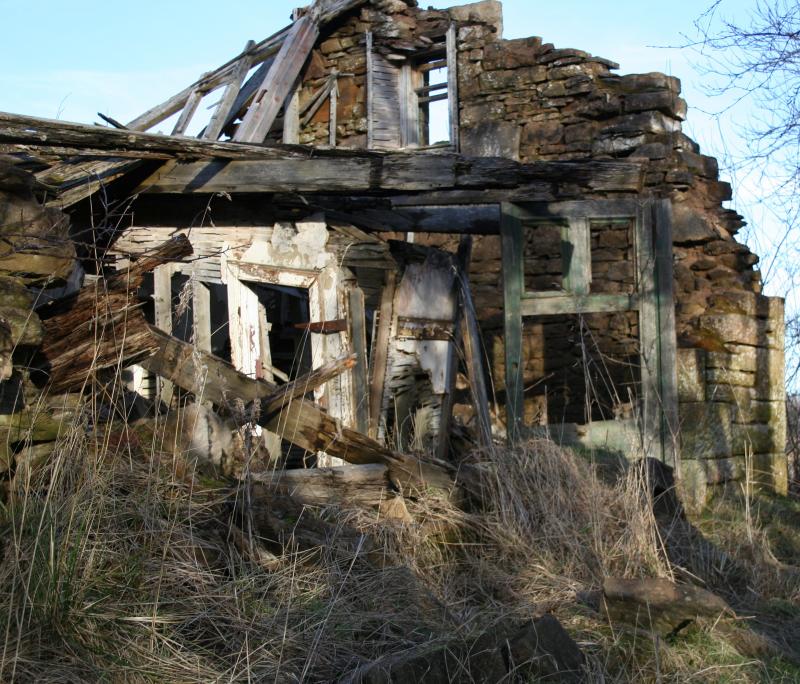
[0,404,800,682]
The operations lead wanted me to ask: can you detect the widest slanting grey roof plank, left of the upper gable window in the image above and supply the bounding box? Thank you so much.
[233,16,319,143]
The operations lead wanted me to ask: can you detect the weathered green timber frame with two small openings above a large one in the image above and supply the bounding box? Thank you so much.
[501,199,678,466]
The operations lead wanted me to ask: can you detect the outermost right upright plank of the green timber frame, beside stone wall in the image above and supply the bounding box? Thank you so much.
[654,199,680,467]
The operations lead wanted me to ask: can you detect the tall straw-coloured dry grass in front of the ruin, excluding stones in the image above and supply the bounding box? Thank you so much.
[0,398,796,682]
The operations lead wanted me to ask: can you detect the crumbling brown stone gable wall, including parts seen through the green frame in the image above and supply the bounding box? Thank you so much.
[284,0,786,500]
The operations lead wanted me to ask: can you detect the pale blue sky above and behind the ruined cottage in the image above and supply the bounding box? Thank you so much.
[0,0,788,294]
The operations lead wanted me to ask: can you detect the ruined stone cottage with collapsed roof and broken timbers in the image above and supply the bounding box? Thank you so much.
[0,0,787,501]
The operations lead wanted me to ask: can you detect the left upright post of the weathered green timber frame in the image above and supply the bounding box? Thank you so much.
[500,202,524,442]
